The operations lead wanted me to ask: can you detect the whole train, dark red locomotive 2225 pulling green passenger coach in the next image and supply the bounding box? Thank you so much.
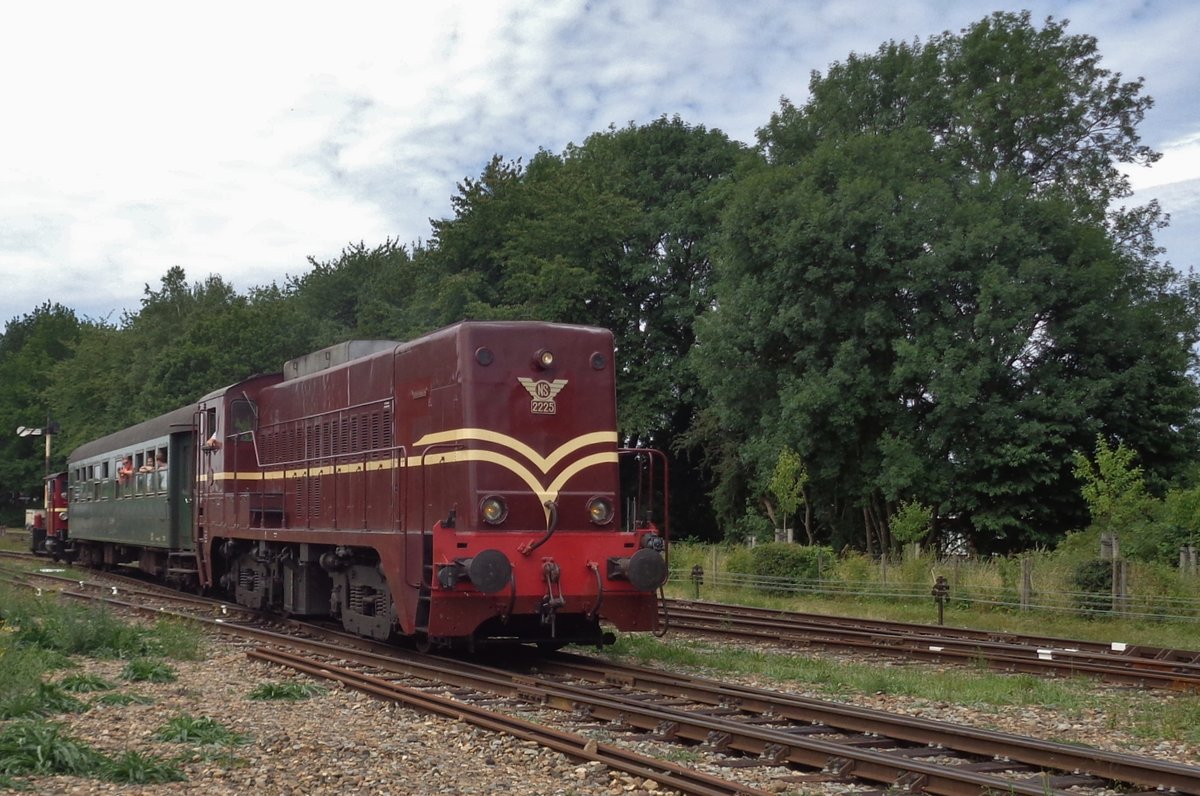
[42,322,670,650]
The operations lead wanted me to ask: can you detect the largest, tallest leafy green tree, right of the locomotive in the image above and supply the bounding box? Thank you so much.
[694,14,1198,549]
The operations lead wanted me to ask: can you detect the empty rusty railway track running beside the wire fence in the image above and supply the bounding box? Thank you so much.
[666,600,1200,692]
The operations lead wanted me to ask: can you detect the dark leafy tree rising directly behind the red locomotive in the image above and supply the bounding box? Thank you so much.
[416,118,743,535]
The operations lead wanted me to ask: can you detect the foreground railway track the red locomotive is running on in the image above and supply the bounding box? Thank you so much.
[4,564,1200,796]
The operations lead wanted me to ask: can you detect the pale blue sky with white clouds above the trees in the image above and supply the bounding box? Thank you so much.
[0,0,1200,324]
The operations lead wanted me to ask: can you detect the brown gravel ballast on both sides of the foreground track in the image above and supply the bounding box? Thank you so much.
[23,636,1200,796]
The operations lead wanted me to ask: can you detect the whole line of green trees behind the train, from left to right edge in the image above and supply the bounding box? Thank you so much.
[0,12,1200,552]
